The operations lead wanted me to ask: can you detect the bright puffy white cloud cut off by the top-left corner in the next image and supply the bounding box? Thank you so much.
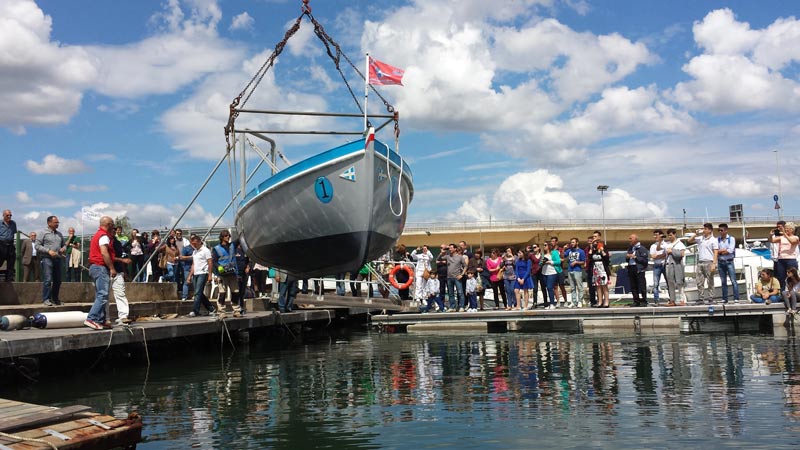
[0,0,97,134]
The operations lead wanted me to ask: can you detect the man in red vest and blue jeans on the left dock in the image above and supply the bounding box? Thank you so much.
[83,216,117,330]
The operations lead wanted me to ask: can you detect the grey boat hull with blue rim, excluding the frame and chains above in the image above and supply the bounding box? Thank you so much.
[235,128,414,278]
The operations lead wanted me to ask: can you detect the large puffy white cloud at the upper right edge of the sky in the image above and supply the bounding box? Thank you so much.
[671,9,800,113]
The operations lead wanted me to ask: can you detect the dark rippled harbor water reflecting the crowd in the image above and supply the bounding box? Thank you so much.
[3,331,800,449]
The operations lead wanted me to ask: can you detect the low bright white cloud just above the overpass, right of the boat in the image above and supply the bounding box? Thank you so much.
[452,169,667,220]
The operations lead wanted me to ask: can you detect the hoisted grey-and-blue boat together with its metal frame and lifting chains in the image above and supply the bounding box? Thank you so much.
[225,0,414,278]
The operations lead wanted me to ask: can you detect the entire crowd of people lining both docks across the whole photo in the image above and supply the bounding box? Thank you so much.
[0,210,800,328]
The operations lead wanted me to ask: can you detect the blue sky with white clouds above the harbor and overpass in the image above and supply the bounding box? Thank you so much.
[0,0,800,237]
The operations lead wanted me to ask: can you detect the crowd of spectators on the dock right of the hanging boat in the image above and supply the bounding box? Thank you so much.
[395,221,800,315]
